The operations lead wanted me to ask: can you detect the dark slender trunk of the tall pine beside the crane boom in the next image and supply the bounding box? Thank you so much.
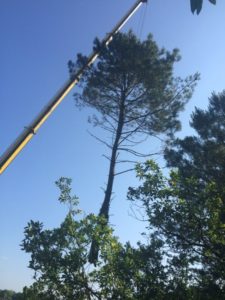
[89,92,126,264]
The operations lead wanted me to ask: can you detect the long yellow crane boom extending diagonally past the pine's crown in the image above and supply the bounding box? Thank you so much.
[0,0,147,174]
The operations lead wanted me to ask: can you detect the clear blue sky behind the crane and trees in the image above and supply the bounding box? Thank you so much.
[0,0,225,290]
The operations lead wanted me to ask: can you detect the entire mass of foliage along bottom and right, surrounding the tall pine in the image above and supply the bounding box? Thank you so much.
[22,93,225,300]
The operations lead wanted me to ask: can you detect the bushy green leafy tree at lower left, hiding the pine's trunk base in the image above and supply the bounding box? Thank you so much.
[22,178,172,300]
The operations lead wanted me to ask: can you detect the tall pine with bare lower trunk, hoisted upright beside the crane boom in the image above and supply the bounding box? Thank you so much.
[69,31,198,263]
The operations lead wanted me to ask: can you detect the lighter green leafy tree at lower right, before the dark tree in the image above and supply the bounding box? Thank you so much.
[128,161,225,299]
